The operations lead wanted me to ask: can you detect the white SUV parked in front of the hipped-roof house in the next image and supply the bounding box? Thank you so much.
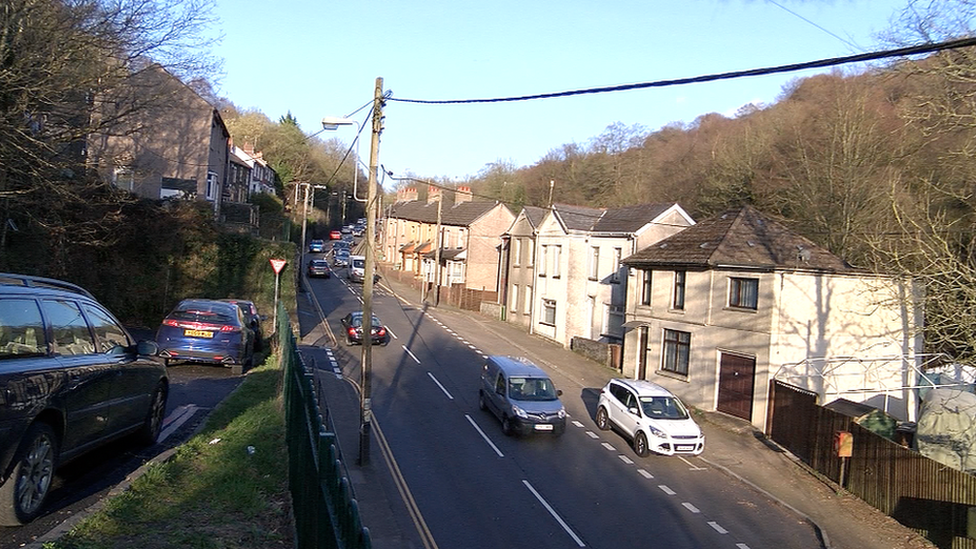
[596,379,705,457]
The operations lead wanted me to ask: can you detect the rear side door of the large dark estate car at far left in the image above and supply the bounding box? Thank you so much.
[41,299,115,455]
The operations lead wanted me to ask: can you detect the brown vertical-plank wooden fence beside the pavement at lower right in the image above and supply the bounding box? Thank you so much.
[768,380,976,549]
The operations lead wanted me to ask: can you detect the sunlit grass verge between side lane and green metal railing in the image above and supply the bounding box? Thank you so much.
[44,355,293,549]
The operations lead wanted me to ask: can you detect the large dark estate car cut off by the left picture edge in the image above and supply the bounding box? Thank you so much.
[0,274,169,526]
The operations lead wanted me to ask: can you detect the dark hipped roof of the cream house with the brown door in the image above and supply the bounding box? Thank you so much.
[622,206,859,272]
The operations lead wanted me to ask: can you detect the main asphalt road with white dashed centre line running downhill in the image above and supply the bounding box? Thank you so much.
[310,260,820,549]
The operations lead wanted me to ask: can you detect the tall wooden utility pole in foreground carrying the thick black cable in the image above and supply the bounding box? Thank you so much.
[359,78,383,465]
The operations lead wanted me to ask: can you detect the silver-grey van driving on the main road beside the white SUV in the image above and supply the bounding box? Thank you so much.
[478,356,566,436]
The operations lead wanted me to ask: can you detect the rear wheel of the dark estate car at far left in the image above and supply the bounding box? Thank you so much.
[0,423,58,526]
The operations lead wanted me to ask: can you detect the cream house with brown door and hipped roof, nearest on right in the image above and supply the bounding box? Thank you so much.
[623,206,922,429]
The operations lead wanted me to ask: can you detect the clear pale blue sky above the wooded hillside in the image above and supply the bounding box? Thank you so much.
[215,0,907,180]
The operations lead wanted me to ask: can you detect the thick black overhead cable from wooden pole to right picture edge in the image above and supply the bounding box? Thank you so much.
[388,37,976,105]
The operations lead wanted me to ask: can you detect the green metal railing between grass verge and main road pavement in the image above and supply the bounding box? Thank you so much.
[277,306,372,549]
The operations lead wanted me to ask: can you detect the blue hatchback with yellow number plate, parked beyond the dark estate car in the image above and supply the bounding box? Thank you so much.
[156,299,254,374]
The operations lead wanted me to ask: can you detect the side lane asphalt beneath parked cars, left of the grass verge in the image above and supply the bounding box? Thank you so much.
[0,360,243,549]
